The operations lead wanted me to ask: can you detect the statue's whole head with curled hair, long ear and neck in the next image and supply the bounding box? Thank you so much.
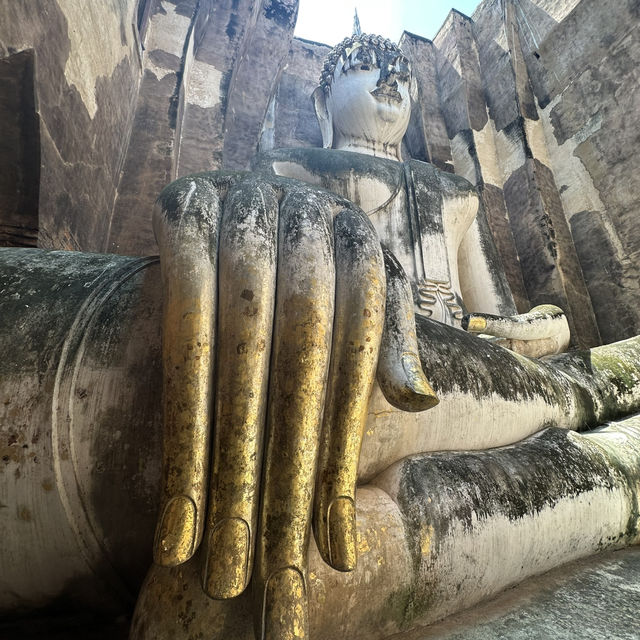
[313,34,411,160]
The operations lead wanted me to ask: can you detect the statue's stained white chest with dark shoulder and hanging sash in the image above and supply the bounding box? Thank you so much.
[262,149,476,326]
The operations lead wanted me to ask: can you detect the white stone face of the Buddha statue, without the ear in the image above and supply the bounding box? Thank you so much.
[327,45,411,149]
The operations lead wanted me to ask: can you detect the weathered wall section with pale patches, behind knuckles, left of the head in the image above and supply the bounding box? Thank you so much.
[107,0,298,255]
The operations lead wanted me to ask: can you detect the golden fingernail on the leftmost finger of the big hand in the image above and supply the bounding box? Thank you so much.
[153,496,196,567]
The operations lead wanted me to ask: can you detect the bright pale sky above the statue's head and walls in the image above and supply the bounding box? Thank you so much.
[295,0,479,46]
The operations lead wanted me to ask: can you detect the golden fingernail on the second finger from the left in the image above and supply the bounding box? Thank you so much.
[202,518,251,599]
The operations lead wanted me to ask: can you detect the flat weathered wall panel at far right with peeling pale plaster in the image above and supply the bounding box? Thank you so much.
[520,0,640,342]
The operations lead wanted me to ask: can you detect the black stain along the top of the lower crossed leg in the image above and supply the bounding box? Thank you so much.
[390,428,638,610]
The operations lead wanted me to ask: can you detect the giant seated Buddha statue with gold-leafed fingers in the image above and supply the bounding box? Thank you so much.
[3,35,640,640]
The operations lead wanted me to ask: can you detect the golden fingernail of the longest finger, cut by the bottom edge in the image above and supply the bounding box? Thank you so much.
[262,567,309,640]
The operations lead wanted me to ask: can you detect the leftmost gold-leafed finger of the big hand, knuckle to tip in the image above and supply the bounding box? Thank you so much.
[153,178,220,566]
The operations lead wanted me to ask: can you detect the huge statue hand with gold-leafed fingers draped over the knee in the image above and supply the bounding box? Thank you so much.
[154,172,437,639]
